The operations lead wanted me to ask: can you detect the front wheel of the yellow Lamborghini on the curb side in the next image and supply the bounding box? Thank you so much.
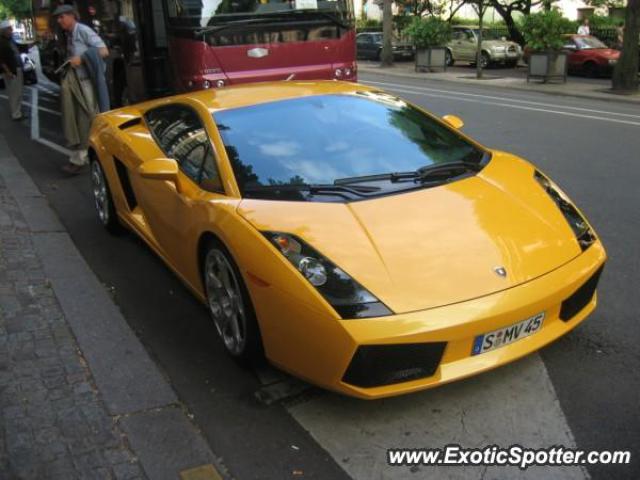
[201,239,264,366]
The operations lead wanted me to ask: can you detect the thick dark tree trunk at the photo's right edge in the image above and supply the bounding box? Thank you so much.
[612,0,640,92]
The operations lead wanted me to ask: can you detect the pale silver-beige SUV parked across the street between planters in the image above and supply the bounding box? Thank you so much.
[446,27,522,68]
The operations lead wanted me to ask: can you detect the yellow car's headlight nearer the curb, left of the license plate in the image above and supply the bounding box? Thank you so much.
[263,232,393,319]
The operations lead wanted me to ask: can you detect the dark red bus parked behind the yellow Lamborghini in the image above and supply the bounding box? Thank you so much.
[34,0,356,106]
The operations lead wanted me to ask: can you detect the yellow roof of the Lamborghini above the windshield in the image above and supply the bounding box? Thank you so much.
[131,80,377,111]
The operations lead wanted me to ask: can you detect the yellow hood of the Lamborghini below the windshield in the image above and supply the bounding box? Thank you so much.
[238,153,580,313]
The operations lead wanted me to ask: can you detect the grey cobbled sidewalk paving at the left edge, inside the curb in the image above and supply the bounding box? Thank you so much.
[0,176,146,480]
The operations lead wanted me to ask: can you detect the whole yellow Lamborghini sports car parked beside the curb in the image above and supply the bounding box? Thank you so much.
[90,82,606,398]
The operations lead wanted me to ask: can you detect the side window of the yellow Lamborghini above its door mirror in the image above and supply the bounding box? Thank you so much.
[145,105,224,192]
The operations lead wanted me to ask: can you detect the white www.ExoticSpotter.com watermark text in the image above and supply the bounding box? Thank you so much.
[387,445,631,470]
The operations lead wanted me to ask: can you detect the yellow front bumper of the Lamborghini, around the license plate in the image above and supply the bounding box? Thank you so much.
[267,241,606,399]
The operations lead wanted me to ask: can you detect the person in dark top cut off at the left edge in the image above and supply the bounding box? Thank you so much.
[0,20,25,120]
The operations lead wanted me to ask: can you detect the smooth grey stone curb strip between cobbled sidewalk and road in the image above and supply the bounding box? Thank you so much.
[0,135,231,480]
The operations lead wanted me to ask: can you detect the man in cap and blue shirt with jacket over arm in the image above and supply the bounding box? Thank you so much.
[53,5,109,175]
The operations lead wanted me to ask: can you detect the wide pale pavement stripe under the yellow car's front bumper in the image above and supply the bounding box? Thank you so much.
[288,354,589,480]
